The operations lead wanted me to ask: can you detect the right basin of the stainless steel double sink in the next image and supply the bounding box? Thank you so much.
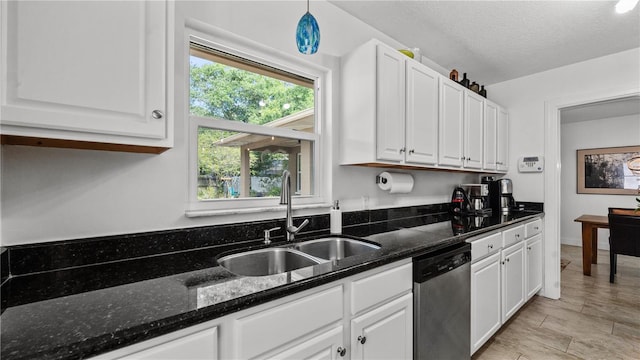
[295,237,380,260]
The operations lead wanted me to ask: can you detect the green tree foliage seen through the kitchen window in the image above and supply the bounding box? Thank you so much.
[190,55,314,199]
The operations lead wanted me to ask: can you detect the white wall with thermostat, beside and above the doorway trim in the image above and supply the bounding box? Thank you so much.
[487,48,640,202]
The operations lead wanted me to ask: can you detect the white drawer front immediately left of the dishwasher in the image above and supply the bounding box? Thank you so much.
[351,263,413,314]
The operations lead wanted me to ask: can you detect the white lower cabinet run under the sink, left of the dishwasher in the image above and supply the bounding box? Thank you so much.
[95,259,413,360]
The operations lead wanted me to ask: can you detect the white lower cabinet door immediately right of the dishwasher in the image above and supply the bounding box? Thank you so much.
[471,253,502,354]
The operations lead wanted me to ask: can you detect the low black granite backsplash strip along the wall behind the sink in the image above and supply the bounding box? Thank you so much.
[6,203,543,276]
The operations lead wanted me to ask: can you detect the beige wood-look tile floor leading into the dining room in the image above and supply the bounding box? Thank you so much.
[472,245,640,360]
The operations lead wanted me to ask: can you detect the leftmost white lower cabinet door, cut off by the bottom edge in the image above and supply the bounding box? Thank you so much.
[118,327,218,360]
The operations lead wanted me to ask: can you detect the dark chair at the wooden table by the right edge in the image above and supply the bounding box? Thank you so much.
[609,208,640,283]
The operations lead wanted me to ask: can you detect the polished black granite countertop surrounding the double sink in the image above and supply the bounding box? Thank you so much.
[0,211,543,360]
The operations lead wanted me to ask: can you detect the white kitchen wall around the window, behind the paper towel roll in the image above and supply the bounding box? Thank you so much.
[0,1,470,245]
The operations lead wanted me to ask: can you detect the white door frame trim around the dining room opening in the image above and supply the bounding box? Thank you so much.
[542,88,640,299]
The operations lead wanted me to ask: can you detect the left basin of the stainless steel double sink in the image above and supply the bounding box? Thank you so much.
[218,248,324,276]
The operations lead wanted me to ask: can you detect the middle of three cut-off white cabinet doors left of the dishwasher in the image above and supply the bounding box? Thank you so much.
[268,326,346,360]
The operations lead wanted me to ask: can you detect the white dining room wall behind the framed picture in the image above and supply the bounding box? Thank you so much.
[560,115,640,250]
